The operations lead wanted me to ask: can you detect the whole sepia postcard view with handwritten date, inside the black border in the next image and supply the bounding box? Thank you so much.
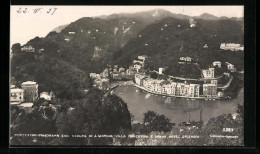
[9,5,246,147]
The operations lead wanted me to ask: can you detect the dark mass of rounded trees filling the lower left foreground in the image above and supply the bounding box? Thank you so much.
[11,89,131,145]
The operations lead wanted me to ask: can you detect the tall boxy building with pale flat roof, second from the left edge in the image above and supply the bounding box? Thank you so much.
[21,81,38,102]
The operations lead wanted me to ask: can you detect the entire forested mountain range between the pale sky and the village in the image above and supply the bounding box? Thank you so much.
[11,10,244,97]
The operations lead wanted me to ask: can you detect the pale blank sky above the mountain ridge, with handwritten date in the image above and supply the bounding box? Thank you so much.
[10,5,244,45]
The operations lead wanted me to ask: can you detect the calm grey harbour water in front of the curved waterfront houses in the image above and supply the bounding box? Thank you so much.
[114,86,244,123]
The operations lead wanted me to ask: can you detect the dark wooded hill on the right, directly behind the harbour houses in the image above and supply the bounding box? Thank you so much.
[113,18,244,72]
